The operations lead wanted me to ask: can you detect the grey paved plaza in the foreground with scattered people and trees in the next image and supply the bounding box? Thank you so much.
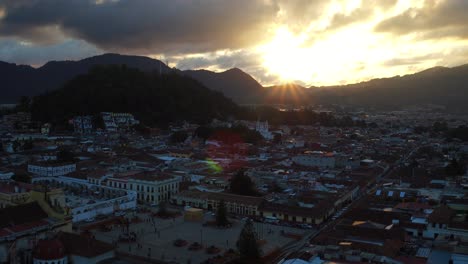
[92,209,305,263]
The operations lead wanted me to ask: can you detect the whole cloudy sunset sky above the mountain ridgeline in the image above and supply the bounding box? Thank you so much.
[0,0,468,86]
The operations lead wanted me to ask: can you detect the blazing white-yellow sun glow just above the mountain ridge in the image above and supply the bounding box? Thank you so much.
[259,24,394,85]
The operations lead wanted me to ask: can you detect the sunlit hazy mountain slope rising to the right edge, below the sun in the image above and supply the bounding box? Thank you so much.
[311,64,468,111]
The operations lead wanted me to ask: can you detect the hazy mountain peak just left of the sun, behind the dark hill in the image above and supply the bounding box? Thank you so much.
[183,68,264,103]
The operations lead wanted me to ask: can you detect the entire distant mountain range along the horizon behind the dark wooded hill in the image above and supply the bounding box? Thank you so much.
[0,54,468,110]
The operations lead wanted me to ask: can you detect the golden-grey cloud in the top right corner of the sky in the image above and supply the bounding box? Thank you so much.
[375,0,468,39]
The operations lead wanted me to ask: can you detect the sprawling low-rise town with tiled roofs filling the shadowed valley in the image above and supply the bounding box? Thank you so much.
[0,106,468,264]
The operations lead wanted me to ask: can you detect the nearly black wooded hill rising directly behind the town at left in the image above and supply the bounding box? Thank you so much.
[31,65,239,126]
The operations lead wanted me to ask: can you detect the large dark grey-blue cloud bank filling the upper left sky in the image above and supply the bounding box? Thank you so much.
[0,0,278,54]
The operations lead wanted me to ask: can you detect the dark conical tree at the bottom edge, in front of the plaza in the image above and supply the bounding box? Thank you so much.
[237,220,261,263]
